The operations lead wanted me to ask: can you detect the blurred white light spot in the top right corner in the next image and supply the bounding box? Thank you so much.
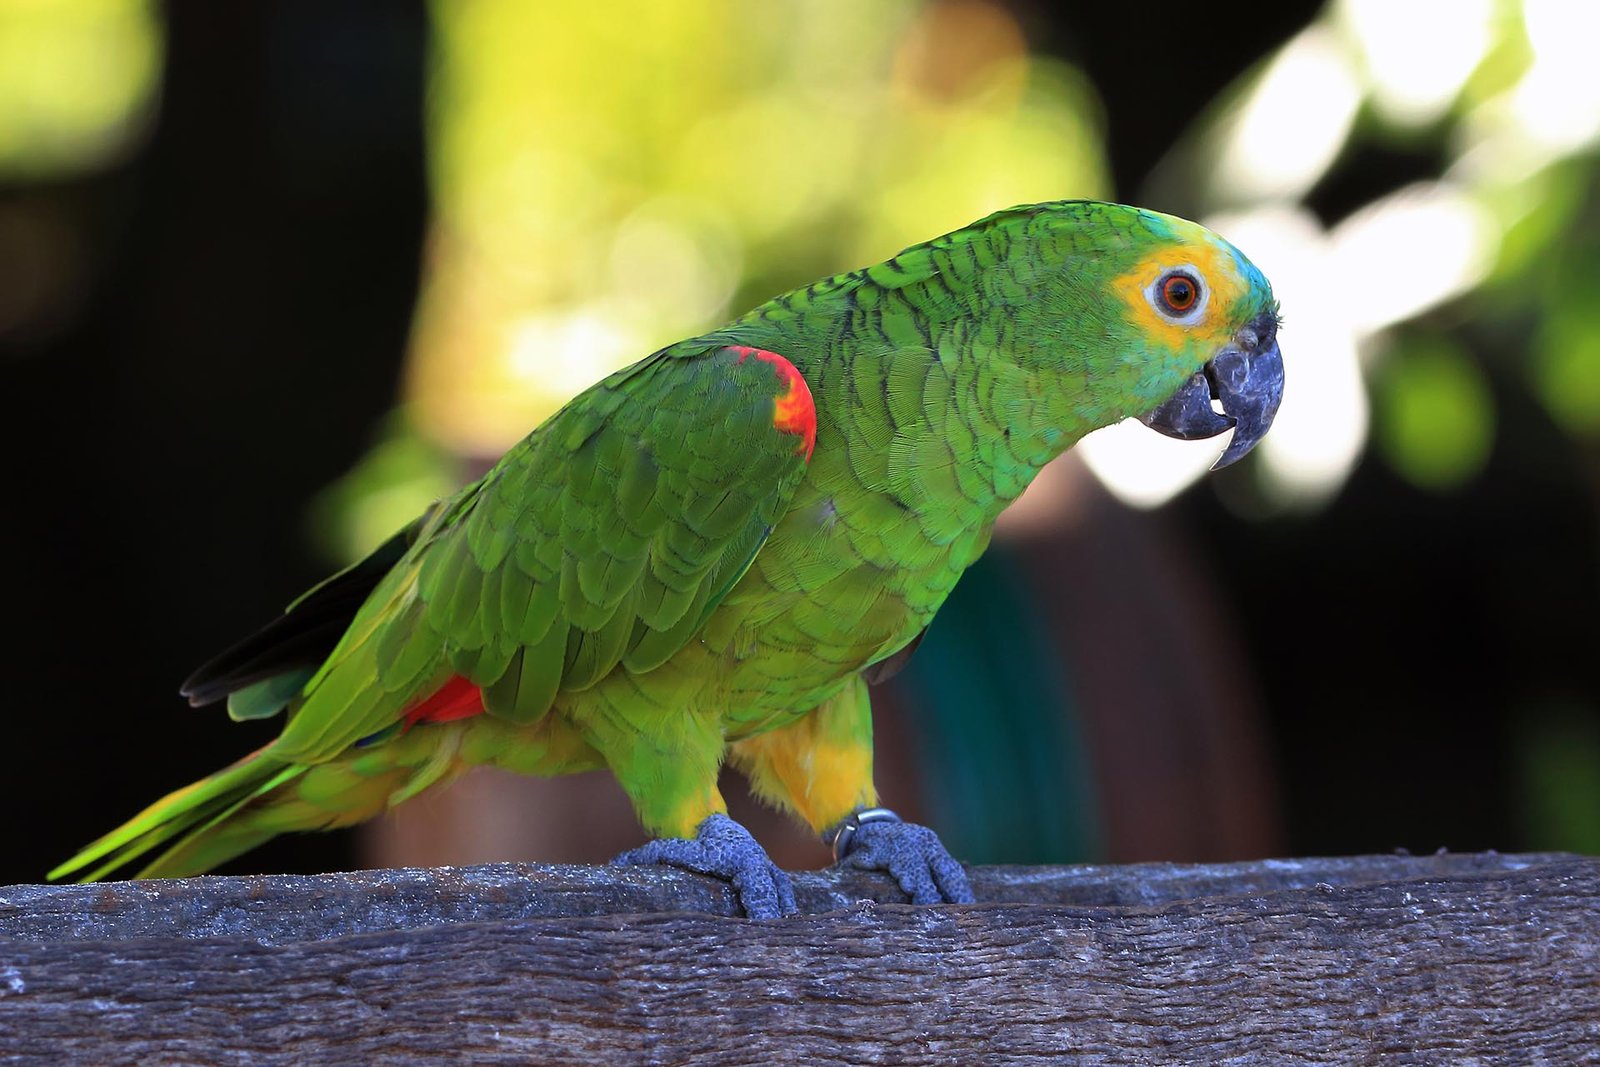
[1510,0,1600,152]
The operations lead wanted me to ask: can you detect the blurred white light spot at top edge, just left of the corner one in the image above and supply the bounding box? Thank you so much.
[1338,0,1494,125]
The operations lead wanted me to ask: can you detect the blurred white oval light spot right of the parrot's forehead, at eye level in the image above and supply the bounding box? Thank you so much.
[1324,182,1499,334]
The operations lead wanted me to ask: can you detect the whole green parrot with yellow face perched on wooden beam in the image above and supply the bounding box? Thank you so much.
[50,200,1283,918]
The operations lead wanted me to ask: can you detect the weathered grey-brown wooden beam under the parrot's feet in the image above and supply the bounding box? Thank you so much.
[0,854,1600,1064]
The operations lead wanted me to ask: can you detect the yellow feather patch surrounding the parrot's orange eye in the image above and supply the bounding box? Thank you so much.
[1112,219,1250,349]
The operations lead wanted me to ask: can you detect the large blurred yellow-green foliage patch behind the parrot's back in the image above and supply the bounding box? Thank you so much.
[408,0,1107,456]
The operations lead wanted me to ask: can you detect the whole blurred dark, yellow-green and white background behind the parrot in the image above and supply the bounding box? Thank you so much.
[0,0,1600,881]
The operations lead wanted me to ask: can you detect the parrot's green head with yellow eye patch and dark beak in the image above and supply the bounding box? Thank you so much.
[1024,202,1283,469]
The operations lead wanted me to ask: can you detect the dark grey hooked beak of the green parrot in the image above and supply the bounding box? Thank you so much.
[1139,312,1283,470]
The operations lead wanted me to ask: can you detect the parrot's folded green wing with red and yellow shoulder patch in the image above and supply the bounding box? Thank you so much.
[272,342,816,763]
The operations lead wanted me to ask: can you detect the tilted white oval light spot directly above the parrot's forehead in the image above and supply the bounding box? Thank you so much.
[1211,26,1362,203]
